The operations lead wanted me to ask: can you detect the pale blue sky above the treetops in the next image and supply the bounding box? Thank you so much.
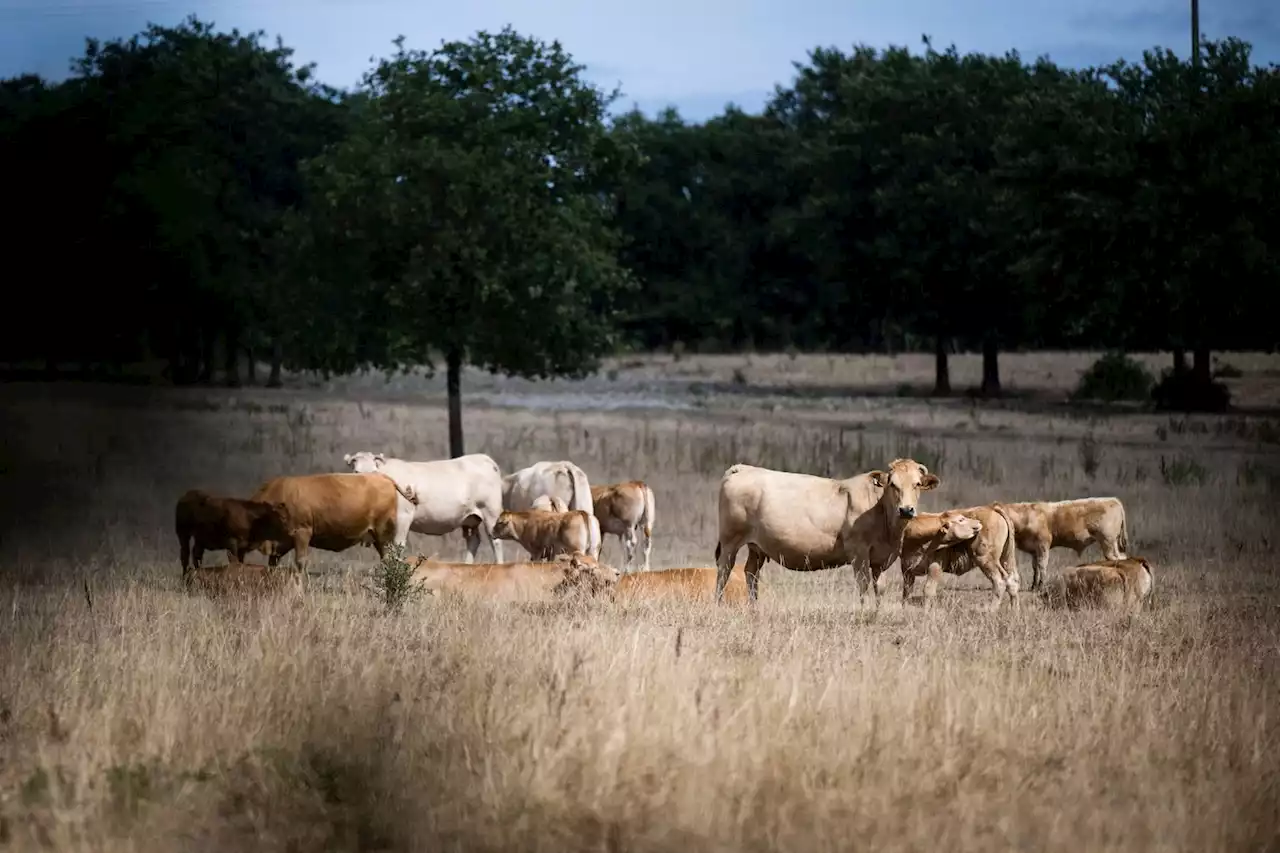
[0,0,1280,120]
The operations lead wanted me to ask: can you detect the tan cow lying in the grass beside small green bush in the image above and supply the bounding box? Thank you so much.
[411,552,621,601]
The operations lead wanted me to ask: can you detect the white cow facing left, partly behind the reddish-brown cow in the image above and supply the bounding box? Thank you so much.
[342,451,502,562]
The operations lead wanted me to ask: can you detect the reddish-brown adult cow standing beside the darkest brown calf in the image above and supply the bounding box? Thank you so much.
[252,474,417,570]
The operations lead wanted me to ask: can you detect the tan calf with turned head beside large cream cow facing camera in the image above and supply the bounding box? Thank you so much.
[899,503,1020,610]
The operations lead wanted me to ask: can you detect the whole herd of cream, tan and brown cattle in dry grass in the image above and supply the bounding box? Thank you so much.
[174,451,1155,611]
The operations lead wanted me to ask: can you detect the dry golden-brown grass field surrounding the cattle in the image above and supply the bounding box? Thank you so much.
[0,356,1280,853]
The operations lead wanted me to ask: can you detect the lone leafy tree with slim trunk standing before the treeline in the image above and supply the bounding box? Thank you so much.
[310,27,634,456]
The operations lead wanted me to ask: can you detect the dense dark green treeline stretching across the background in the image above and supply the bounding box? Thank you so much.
[0,18,1280,446]
